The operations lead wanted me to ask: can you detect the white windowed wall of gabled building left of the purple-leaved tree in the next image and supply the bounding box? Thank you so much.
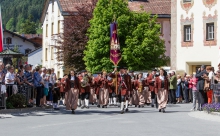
[42,0,64,76]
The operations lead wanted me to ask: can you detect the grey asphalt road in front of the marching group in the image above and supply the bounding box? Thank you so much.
[0,104,220,136]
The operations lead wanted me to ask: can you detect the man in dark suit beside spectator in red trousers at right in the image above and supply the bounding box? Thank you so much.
[196,65,208,110]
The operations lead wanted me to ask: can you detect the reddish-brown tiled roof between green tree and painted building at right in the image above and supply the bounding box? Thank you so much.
[128,0,171,14]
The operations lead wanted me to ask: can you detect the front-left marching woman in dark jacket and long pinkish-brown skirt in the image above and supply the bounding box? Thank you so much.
[66,70,80,114]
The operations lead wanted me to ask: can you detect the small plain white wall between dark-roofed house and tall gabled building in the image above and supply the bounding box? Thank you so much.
[28,48,42,66]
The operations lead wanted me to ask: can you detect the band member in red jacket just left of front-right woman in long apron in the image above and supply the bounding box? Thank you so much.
[147,69,158,108]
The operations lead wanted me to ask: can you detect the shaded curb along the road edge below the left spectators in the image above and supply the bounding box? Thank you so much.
[0,107,53,114]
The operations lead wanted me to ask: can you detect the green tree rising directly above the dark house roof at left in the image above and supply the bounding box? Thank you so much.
[20,15,37,34]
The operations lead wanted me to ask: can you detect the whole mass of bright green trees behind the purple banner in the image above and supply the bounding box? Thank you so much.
[84,0,166,72]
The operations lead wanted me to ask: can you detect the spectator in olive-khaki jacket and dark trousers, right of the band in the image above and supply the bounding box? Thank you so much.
[169,71,177,104]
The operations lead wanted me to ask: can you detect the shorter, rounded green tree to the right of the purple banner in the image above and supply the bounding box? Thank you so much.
[122,12,167,70]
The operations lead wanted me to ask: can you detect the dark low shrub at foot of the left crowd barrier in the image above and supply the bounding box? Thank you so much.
[6,94,26,109]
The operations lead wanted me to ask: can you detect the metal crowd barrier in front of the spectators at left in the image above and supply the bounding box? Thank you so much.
[0,83,36,109]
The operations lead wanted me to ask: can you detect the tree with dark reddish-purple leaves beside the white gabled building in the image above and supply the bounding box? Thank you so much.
[54,3,95,70]
